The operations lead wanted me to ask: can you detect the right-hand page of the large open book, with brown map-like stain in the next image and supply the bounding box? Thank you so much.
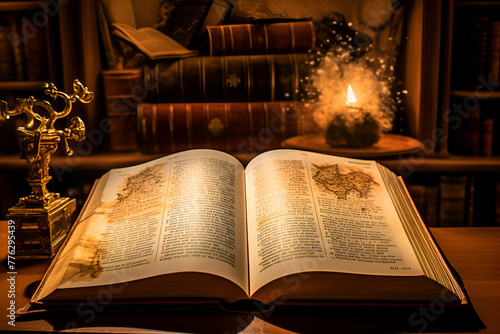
[246,150,423,294]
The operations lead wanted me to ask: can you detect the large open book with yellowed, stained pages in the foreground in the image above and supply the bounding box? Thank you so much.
[31,149,467,304]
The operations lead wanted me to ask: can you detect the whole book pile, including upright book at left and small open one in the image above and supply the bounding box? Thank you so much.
[101,2,315,153]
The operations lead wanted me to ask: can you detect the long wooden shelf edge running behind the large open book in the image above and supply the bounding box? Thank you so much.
[0,152,500,174]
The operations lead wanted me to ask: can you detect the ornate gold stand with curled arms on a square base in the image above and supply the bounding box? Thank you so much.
[0,80,94,259]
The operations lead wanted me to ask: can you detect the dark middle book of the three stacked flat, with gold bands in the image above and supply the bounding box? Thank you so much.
[144,54,310,103]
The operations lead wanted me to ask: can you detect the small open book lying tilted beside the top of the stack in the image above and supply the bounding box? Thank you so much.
[111,23,198,60]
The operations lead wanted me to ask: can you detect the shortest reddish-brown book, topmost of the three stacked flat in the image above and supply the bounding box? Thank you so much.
[207,21,315,56]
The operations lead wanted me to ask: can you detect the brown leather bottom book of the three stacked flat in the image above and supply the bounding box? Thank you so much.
[137,102,313,153]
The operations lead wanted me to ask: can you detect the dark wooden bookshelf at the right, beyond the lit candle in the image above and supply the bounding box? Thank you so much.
[405,0,500,226]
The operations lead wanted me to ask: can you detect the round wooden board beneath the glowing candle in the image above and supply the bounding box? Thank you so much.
[281,134,423,158]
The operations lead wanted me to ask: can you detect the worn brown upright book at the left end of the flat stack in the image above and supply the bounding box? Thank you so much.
[102,69,142,151]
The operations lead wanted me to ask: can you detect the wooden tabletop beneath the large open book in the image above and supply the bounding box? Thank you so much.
[0,221,500,333]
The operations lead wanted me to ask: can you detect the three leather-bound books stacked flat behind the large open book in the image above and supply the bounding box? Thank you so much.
[137,21,314,153]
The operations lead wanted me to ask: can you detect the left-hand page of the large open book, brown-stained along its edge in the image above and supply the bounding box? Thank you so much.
[33,150,248,300]
